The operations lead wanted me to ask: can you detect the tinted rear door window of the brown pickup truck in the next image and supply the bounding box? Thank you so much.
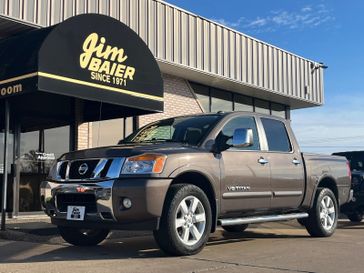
[261,118,292,152]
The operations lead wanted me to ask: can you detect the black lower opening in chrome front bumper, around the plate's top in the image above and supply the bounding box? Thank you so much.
[56,193,97,213]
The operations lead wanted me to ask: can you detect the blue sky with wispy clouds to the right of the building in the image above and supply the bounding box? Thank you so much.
[167,0,364,154]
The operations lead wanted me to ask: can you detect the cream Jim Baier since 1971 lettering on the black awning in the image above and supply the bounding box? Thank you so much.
[80,33,135,86]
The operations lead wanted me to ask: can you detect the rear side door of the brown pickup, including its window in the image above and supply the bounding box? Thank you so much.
[260,118,305,209]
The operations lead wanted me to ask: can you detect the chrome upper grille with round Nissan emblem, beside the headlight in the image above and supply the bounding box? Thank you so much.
[56,157,125,181]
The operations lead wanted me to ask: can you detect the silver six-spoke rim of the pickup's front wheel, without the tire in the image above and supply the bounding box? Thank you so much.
[175,196,206,246]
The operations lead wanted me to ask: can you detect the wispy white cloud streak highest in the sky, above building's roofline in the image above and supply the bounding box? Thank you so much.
[213,4,335,32]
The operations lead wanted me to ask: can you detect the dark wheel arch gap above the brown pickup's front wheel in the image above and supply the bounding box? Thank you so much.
[170,171,218,232]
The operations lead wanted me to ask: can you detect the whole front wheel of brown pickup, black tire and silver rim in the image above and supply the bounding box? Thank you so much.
[153,184,212,256]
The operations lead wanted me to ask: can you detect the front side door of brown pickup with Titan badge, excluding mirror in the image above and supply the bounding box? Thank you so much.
[216,116,272,213]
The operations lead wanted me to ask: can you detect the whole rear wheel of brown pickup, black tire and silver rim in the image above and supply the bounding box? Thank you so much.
[303,188,339,237]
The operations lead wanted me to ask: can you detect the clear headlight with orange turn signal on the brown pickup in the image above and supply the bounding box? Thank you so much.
[121,154,167,174]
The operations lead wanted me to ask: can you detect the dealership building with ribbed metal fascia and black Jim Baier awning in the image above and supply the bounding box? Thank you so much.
[0,0,324,215]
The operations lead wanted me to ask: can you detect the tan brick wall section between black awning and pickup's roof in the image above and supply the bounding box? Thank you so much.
[139,74,203,127]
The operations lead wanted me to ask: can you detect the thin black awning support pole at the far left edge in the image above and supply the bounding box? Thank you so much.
[1,100,10,231]
